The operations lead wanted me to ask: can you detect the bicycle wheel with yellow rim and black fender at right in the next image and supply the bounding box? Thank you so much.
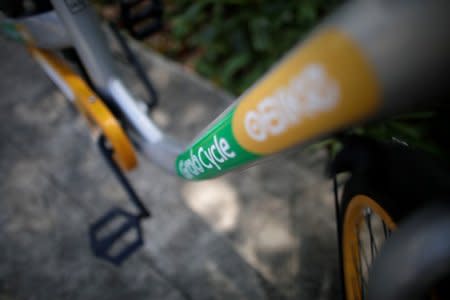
[338,141,450,300]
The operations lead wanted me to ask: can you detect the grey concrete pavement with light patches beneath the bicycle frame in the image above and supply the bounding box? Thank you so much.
[0,32,338,300]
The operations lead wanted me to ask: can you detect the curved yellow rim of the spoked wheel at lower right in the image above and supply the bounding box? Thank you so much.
[342,195,396,300]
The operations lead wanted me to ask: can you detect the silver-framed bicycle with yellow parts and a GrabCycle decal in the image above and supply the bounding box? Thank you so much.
[3,0,450,299]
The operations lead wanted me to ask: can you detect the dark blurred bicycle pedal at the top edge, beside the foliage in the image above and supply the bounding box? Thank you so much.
[120,0,163,40]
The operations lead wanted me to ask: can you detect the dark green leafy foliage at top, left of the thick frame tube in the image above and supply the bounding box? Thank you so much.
[165,0,340,94]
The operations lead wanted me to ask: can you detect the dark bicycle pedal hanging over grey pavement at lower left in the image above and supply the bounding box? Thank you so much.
[89,208,144,265]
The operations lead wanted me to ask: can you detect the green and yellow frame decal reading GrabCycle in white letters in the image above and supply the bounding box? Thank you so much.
[176,28,381,179]
